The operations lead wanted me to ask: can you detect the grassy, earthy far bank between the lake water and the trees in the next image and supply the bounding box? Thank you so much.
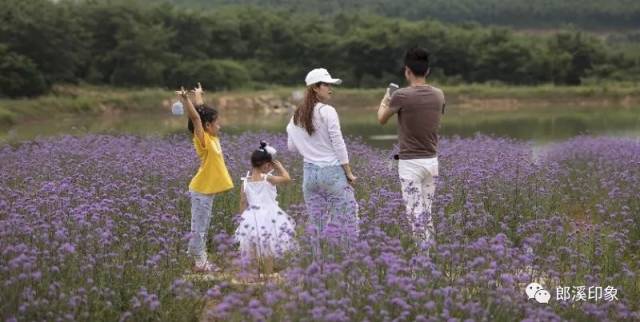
[0,83,640,127]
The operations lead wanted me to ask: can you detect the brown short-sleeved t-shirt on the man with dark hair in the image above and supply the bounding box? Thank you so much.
[389,85,445,160]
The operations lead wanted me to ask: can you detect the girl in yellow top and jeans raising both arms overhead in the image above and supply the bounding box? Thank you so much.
[176,83,233,273]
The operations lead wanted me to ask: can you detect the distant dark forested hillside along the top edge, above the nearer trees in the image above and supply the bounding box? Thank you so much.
[161,0,640,29]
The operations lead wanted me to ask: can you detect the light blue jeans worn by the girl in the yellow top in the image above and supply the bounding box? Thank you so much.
[188,191,215,263]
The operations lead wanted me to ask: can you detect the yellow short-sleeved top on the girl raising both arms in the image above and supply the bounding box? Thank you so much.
[189,132,233,194]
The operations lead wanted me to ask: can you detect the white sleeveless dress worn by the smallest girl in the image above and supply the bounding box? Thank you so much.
[235,173,295,257]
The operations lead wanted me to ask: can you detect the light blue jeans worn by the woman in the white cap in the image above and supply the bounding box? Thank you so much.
[302,163,358,235]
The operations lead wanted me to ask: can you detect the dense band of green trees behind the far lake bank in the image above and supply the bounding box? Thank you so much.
[0,0,640,97]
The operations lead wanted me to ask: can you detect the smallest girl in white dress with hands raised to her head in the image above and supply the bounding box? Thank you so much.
[235,141,294,258]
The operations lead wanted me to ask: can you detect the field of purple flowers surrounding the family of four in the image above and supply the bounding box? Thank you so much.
[0,133,640,321]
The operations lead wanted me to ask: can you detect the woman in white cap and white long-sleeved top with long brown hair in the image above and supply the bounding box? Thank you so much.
[287,68,358,235]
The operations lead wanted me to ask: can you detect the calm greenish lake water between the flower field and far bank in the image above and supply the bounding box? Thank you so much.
[0,106,640,147]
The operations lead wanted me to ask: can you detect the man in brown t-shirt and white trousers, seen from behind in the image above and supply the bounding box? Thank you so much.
[378,48,445,246]
